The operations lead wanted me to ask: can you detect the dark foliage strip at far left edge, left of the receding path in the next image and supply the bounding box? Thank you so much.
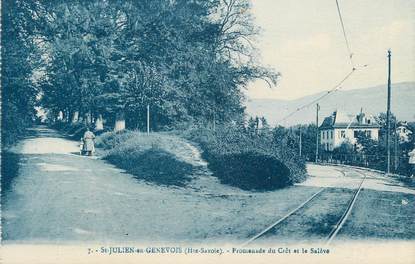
[1,1,40,146]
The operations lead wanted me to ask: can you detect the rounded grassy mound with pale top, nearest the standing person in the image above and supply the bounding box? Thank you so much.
[96,130,195,186]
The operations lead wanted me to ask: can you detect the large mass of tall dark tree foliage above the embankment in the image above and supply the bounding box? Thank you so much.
[4,0,278,136]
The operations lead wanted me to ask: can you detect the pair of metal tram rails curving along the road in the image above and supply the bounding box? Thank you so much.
[241,168,366,247]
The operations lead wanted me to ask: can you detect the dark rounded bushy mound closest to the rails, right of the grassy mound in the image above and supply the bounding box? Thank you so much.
[185,126,306,190]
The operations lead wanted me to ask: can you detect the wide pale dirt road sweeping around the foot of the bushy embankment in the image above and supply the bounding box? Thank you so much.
[2,127,414,243]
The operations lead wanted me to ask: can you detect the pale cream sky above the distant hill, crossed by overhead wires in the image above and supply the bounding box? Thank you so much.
[247,0,415,100]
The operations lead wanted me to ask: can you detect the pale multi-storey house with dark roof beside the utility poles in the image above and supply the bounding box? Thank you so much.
[319,111,380,151]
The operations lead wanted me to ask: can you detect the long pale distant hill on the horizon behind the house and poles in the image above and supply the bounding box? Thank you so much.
[246,82,415,126]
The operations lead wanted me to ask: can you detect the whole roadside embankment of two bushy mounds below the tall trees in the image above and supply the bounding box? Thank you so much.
[49,120,306,191]
